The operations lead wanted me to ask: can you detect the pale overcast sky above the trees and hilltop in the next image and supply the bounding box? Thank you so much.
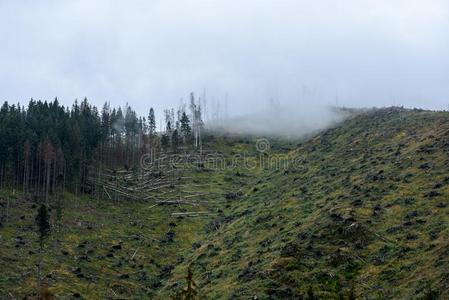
[0,0,449,114]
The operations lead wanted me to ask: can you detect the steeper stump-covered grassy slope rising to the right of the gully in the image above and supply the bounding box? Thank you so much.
[162,108,449,299]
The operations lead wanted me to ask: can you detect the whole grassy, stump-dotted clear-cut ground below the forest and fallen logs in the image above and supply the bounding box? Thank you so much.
[0,108,449,299]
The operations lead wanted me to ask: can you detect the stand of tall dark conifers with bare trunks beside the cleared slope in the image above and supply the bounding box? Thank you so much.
[0,93,204,201]
